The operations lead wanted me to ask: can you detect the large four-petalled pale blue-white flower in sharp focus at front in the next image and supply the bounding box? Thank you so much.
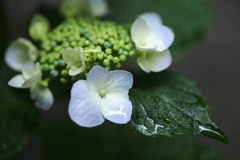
[68,66,133,127]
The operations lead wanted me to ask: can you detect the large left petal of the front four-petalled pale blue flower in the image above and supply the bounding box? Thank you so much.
[68,80,104,127]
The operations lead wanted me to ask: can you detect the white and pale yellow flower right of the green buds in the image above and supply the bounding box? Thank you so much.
[131,13,174,72]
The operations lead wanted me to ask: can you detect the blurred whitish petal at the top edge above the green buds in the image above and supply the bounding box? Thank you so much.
[89,0,108,17]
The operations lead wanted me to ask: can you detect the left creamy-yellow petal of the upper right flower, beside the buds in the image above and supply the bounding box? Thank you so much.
[131,18,157,50]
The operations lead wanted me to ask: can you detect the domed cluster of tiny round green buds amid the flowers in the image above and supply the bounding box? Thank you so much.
[39,17,135,83]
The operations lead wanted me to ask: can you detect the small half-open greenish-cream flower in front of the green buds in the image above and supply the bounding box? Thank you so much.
[62,48,85,76]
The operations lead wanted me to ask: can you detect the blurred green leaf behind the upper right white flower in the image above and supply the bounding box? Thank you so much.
[106,0,212,59]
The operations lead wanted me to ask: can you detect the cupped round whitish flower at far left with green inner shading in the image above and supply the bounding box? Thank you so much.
[5,38,38,71]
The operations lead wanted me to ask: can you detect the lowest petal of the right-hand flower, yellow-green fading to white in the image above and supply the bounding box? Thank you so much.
[138,50,172,72]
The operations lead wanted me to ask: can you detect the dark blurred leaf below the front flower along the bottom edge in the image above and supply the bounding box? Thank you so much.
[37,119,225,160]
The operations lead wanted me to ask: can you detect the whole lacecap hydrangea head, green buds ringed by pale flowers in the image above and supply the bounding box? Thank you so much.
[5,0,174,127]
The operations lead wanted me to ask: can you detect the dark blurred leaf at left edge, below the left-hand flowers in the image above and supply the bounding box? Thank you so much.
[0,82,39,159]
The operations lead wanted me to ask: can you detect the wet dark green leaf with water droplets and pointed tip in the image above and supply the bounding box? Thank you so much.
[129,71,228,143]
